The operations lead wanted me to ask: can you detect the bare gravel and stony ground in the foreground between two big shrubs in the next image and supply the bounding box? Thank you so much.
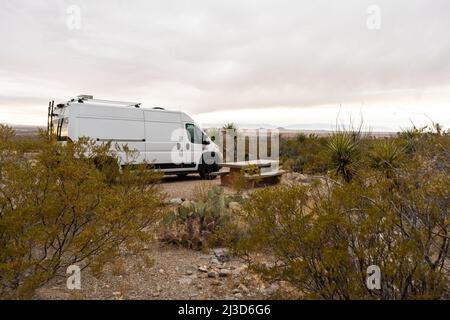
[35,243,278,300]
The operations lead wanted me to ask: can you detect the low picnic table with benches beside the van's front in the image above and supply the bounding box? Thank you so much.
[219,160,285,187]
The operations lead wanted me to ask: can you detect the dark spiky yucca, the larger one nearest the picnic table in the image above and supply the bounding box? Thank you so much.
[327,131,360,182]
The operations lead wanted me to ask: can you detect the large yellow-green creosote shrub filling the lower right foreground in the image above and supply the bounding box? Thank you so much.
[231,130,450,299]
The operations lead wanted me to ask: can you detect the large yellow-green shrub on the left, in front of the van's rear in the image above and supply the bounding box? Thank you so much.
[0,127,160,298]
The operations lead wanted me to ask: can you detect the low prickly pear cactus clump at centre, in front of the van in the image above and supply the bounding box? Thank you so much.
[161,186,229,250]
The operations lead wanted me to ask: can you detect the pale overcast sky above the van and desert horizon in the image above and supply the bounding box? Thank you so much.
[0,0,450,130]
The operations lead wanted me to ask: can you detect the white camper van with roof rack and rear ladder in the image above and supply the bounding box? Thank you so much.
[48,95,222,179]
